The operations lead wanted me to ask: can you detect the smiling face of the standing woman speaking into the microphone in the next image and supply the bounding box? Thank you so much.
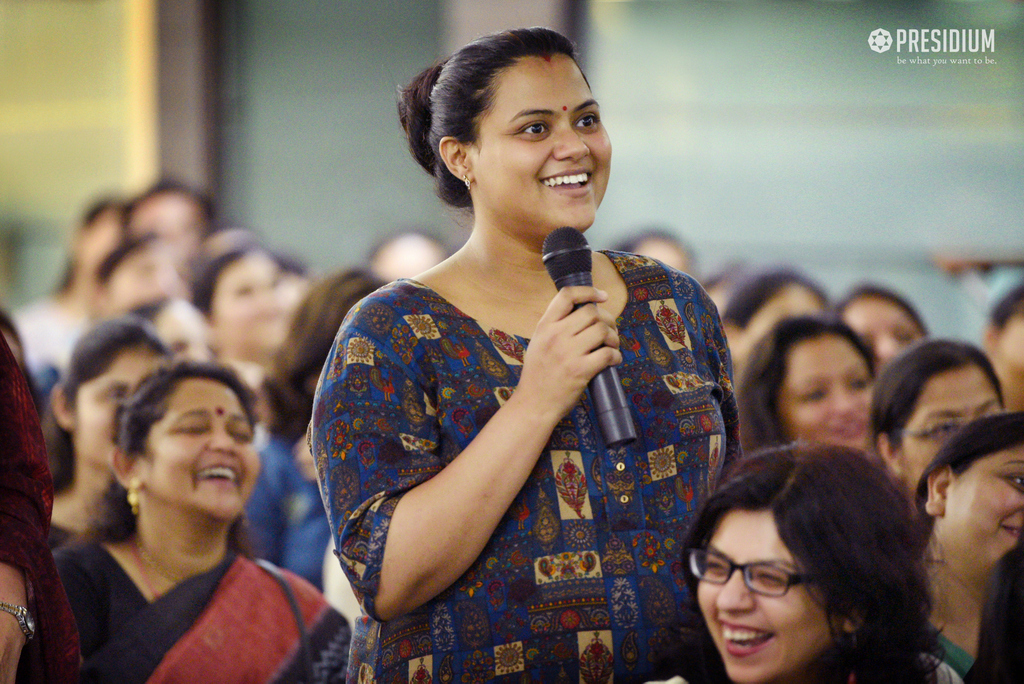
[450,54,611,246]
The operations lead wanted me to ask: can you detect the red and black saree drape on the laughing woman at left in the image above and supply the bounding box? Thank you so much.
[82,557,350,684]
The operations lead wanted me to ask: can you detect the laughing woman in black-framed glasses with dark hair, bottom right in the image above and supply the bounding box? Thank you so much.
[651,445,959,684]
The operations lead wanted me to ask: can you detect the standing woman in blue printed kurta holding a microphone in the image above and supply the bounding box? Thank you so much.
[311,29,739,682]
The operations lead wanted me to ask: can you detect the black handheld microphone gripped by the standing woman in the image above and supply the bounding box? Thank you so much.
[544,226,637,446]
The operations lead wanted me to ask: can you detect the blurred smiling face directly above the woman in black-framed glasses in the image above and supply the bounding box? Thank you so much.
[778,335,871,450]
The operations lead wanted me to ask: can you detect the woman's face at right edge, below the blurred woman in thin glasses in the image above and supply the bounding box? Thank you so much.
[926,444,1024,595]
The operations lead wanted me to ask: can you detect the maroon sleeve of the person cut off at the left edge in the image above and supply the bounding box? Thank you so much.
[0,336,79,684]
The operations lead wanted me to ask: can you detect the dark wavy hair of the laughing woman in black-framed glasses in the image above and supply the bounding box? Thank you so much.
[659,445,938,684]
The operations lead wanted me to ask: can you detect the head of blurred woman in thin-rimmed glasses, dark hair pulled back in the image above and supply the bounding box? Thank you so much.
[871,340,1002,499]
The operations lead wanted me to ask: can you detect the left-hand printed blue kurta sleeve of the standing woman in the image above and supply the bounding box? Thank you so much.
[311,282,444,616]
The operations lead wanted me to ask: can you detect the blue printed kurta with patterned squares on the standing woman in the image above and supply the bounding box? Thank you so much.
[312,252,739,683]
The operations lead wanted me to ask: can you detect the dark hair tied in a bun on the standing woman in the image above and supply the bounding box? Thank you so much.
[398,27,586,209]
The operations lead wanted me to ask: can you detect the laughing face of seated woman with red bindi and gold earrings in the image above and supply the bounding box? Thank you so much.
[131,378,259,525]
